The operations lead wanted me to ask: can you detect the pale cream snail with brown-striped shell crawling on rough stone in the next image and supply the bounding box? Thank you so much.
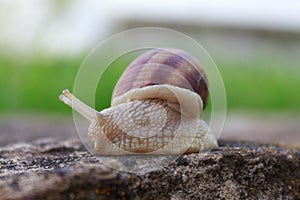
[59,48,218,155]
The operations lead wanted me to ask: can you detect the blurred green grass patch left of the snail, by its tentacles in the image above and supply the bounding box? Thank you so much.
[0,55,81,112]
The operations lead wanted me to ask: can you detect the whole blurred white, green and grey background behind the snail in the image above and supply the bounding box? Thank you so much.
[0,0,300,145]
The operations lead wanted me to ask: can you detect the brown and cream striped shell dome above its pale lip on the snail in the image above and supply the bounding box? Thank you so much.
[112,48,208,107]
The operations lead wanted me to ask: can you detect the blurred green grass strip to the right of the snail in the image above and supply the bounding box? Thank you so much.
[219,61,300,112]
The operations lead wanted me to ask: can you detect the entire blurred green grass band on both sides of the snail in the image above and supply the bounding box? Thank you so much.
[0,54,300,112]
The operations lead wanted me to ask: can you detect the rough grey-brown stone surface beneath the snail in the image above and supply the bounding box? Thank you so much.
[0,140,300,200]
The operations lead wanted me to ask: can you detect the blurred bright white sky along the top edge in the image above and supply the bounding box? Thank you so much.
[0,0,300,54]
